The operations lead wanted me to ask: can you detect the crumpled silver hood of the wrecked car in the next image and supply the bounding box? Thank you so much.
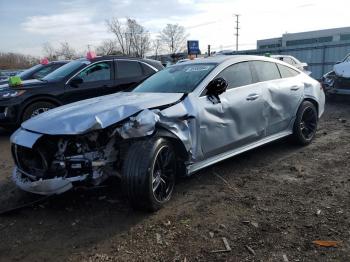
[22,92,183,135]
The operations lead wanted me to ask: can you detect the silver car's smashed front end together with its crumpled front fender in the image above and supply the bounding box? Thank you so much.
[11,102,189,195]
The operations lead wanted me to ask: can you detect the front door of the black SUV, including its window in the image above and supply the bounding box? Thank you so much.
[64,61,115,103]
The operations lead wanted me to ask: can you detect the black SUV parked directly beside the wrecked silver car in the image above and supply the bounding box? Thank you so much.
[0,56,163,128]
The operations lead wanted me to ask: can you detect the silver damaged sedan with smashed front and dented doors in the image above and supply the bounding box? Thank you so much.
[11,56,325,211]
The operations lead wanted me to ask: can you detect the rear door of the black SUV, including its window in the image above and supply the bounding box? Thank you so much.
[115,59,147,91]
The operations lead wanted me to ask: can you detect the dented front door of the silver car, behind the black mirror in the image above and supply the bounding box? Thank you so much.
[199,62,265,158]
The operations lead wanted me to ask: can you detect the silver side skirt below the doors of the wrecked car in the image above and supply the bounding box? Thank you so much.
[187,131,293,175]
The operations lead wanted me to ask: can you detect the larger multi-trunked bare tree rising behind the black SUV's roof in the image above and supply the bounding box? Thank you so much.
[106,18,150,57]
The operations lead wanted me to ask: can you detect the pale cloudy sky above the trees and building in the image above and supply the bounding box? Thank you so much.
[0,0,350,56]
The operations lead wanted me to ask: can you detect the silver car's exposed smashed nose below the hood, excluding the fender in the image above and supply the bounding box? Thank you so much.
[11,129,122,195]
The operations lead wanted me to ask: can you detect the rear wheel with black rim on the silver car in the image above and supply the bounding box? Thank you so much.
[292,101,318,146]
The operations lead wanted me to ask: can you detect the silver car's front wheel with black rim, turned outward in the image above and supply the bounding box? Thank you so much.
[122,138,176,211]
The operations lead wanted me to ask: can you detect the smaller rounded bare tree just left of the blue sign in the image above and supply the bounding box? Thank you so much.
[159,24,188,54]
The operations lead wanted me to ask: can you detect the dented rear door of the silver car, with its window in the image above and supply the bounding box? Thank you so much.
[252,61,303,136]
